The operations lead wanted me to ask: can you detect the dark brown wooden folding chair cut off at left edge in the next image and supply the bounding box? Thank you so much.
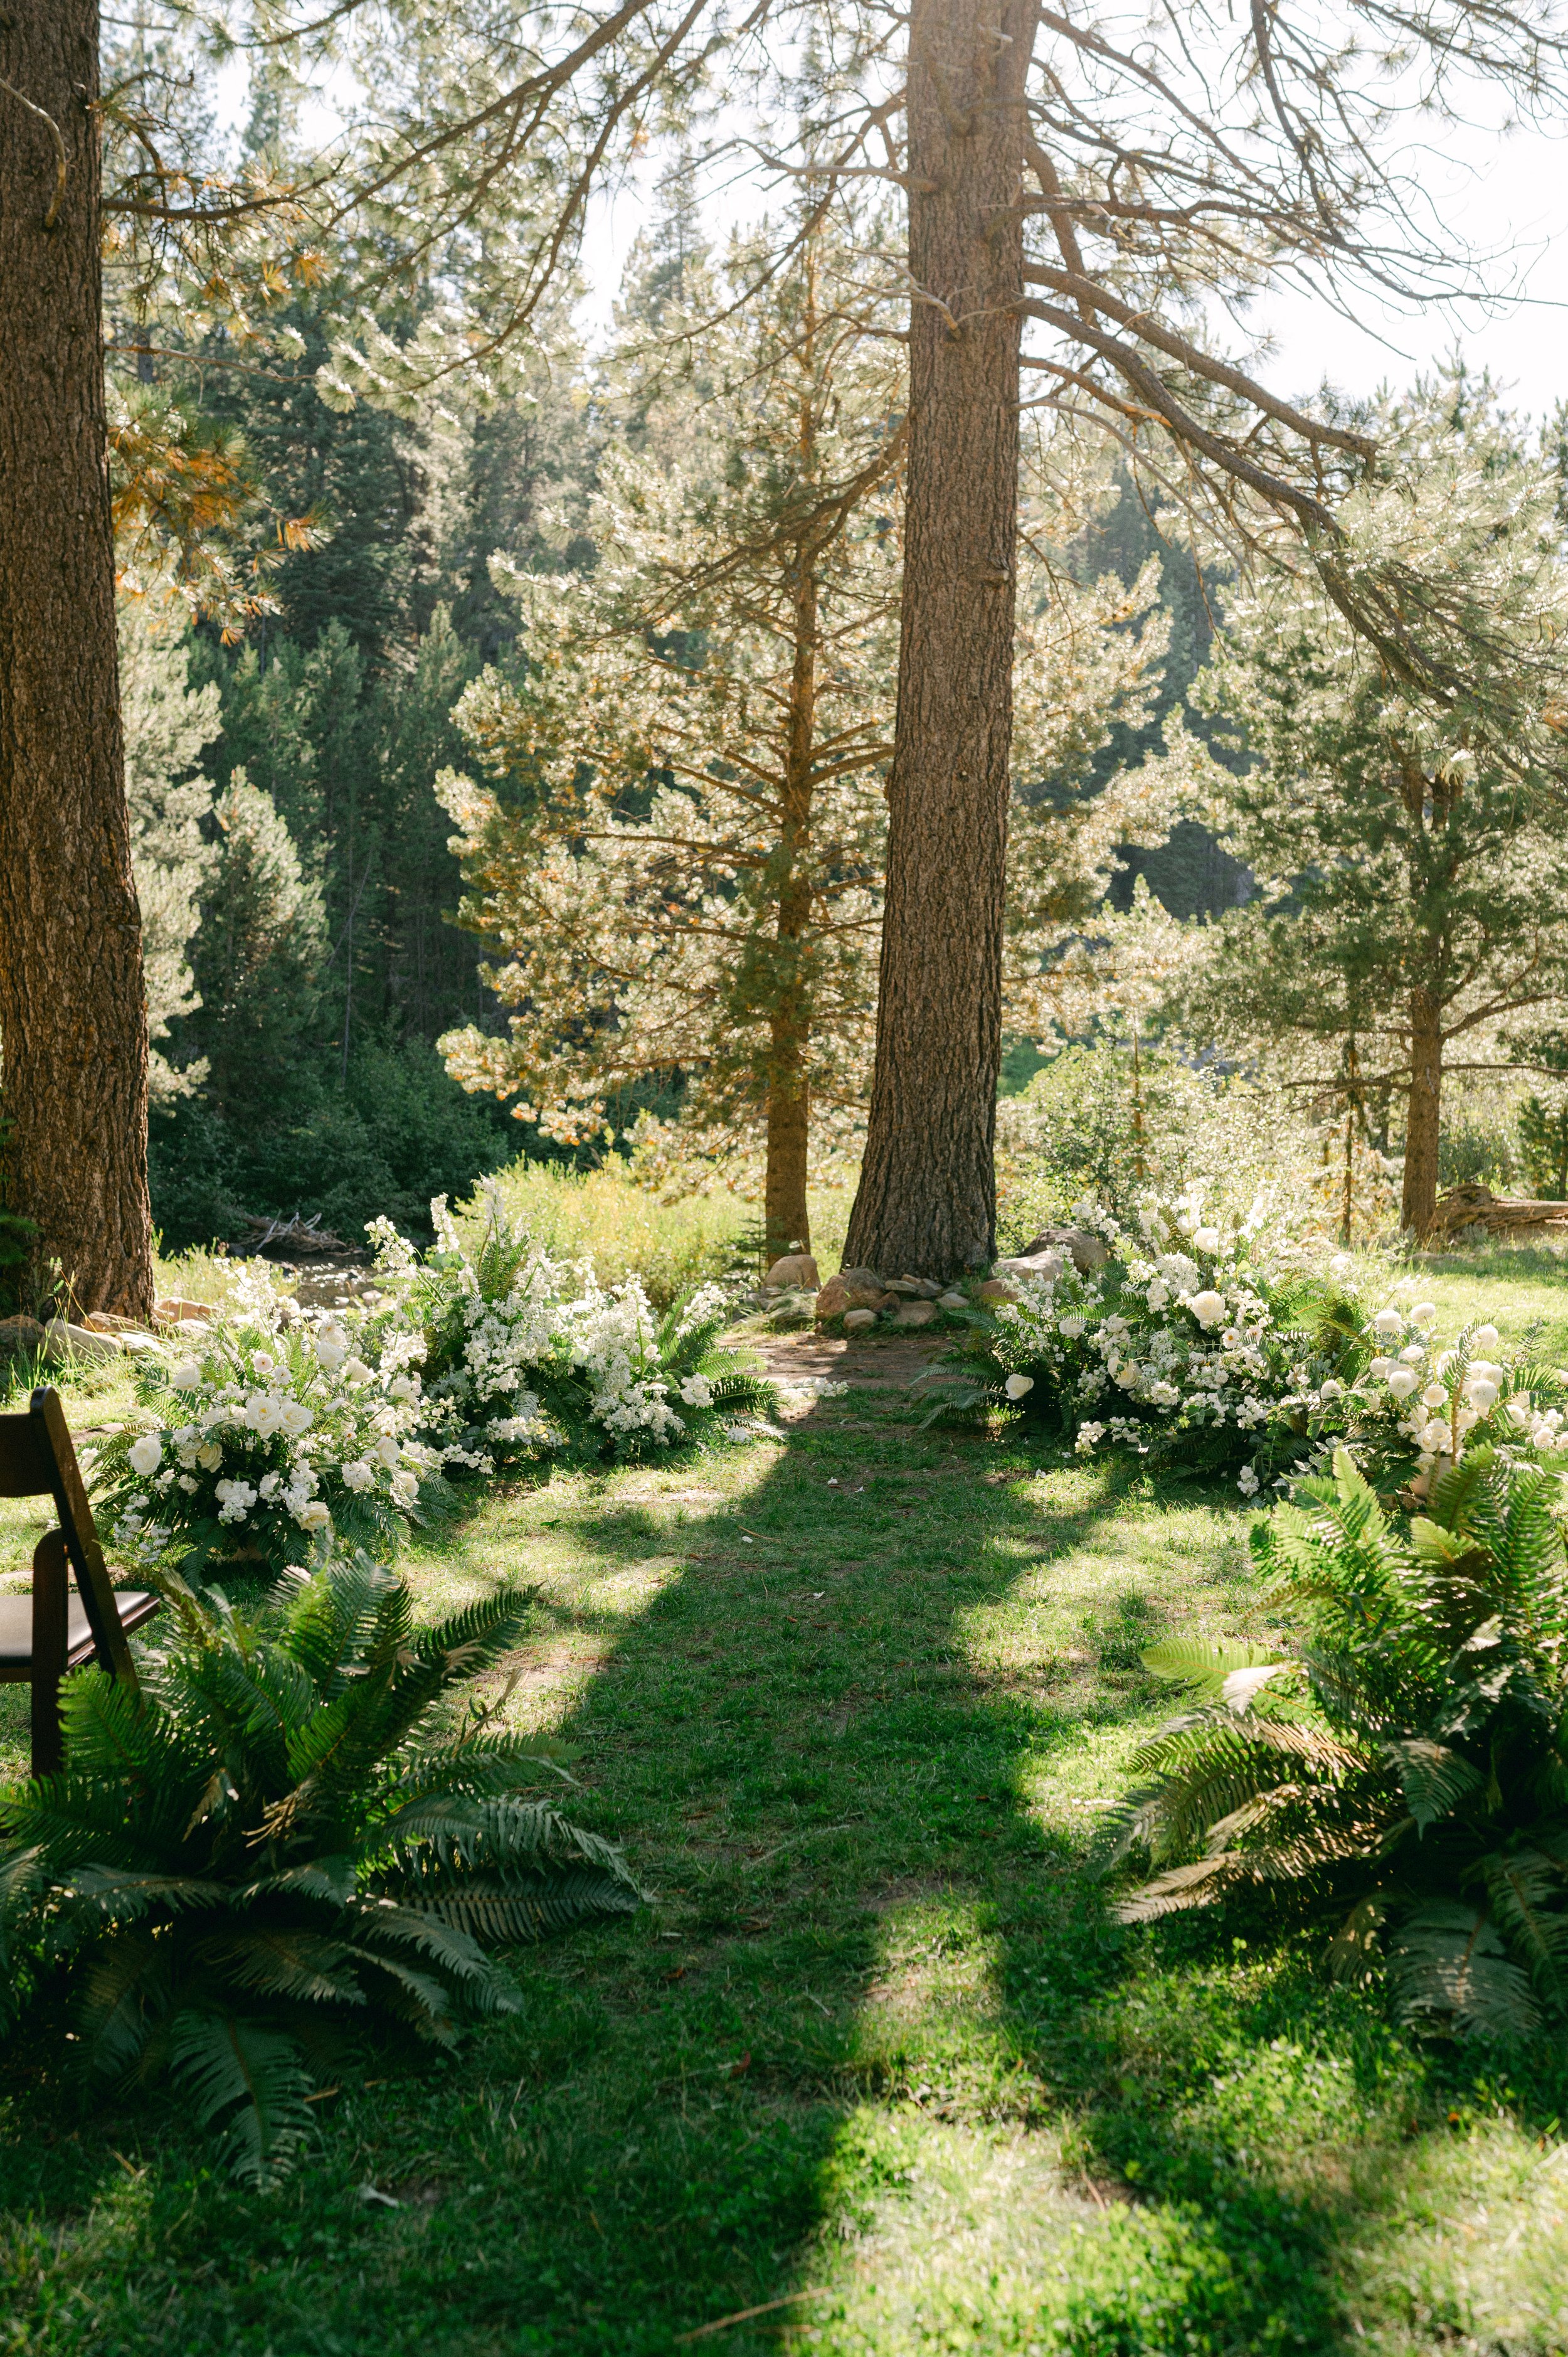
[0,1391,161,1775]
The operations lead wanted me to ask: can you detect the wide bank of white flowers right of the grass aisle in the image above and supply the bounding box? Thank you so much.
[931,1188,1565,1497]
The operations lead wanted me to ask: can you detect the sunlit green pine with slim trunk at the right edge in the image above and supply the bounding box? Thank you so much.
[1179,377,1568,1235]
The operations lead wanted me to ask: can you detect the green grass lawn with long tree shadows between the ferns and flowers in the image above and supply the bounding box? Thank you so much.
[0,1256,1568,2357]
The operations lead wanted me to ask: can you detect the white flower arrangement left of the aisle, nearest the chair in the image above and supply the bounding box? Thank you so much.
[92,1264,443,1575]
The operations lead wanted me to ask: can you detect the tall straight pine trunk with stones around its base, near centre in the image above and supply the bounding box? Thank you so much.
[844,0,1035,1277]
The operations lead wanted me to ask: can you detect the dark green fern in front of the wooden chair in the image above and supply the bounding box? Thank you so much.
[0,1556,637,2180]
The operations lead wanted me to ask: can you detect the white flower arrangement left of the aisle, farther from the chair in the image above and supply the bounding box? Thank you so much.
[373,1193,773,1473]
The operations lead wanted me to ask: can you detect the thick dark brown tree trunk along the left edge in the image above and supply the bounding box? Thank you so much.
[0,0,153,1317]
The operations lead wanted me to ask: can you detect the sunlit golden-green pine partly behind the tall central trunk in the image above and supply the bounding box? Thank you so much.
[443,236,1167,1249]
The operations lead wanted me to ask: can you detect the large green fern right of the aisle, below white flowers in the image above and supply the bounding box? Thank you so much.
[1099,1447,1568,2034]
